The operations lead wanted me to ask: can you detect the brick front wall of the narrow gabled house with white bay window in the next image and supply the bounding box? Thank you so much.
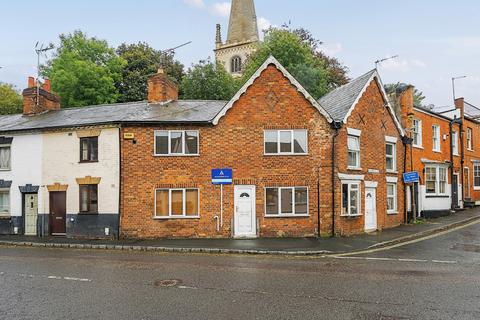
[335,81,405,235]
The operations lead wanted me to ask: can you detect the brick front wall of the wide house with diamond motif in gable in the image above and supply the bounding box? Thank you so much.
[121,66,331,238]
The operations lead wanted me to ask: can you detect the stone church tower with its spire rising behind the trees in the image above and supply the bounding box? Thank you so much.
[214,0,260,76]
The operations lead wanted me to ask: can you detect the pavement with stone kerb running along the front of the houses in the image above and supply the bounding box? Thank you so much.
[0,208,480,255]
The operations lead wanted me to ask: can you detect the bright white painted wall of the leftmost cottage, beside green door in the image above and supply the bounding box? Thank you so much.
[0,134,43,217]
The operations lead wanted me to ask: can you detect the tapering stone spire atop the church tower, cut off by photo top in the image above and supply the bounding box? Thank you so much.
[227,0,259,44]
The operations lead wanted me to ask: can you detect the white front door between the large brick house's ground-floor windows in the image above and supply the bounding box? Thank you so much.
[234,186,257,238]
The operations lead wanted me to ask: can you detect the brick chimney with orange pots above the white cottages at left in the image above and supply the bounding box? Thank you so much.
[22,77,60,115]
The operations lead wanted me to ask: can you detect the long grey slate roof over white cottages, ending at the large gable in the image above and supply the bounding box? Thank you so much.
[0,100,227,132]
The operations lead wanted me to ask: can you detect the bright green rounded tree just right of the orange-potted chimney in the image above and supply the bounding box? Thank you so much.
[42,30,126,107]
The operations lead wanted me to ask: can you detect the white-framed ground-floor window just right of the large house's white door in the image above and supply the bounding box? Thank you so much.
[265,187,308,216]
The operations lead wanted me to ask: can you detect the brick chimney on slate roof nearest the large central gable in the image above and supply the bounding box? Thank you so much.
[148,69,178,104]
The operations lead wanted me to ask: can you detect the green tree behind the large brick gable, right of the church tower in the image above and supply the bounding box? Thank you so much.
[243,27,349,98]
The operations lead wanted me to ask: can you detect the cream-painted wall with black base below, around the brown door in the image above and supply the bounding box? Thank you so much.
[42,128,120,214]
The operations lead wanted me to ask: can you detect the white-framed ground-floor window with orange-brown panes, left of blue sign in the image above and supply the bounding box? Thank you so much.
[155,189,200,218]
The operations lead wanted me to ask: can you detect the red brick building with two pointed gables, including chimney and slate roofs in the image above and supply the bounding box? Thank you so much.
[120,57,404,238]
